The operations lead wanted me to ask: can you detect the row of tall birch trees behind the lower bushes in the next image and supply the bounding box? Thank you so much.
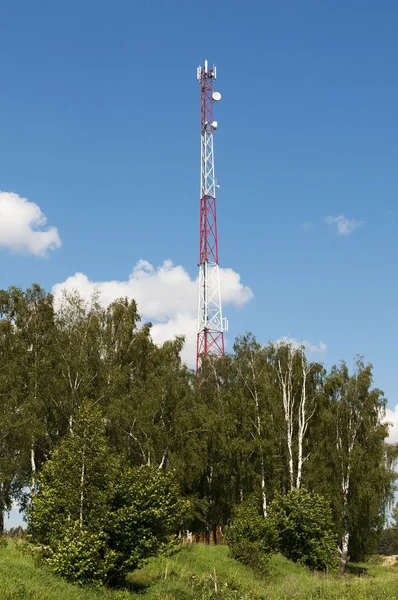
[0,284,397,567]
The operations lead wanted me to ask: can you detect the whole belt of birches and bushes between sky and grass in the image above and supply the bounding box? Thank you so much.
[0,285,396,581]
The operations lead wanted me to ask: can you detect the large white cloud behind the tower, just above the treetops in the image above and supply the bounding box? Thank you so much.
[52,260,253,365]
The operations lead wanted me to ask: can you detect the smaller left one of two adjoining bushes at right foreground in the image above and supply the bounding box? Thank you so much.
[226,495,278,572]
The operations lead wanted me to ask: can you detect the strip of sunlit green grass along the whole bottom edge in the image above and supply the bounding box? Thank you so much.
[0,543,398,600]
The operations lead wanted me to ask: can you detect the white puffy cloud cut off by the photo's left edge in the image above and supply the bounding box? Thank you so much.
[0,192,61,256]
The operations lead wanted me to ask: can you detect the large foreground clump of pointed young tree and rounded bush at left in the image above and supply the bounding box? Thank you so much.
[28,405,185,583]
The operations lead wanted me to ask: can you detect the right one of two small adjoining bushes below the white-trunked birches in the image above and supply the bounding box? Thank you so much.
[269,489,337,570]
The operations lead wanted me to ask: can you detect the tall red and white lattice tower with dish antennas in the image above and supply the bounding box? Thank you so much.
[196,60,228,371]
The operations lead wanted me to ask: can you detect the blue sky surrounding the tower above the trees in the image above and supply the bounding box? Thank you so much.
[0,0,398,524]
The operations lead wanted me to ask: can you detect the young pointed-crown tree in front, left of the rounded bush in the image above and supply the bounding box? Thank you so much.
[28,400,115,545]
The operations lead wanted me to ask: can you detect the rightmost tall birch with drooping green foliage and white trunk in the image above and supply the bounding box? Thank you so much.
[306,357,397,561]
